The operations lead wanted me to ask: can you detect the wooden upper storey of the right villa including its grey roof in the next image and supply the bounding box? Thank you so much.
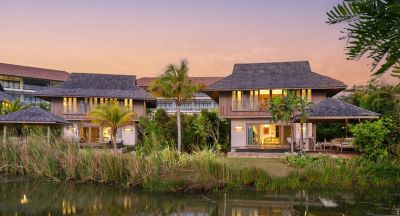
[206,62,346,118]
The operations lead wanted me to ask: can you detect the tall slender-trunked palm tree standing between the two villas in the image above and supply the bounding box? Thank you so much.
[149,60,200,152]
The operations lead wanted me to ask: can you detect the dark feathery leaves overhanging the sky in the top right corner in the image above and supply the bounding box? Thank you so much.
[327,0,400,76]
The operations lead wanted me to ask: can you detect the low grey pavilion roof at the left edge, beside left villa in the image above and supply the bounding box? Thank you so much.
[0,106,68,124]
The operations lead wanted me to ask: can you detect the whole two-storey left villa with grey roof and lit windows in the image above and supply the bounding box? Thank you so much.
[36,73,154,145]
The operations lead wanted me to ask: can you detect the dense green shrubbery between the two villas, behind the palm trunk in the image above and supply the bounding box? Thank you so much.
[138,109,230,154]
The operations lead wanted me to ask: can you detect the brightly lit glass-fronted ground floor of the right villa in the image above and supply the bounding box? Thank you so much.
[231,119,316,151]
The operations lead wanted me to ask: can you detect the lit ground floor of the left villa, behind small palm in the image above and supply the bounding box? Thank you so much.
[64,122,137,145]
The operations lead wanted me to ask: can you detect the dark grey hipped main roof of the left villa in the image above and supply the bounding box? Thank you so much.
[35,73,153,100]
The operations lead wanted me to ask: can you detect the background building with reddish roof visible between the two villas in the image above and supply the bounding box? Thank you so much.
[137,77,222,114]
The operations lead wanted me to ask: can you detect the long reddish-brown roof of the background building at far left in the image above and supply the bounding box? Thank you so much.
[0,63,69,81]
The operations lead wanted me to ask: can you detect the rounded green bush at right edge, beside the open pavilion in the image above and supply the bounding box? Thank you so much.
[350,118,400,160]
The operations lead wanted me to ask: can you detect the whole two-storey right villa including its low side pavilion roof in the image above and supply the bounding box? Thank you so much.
[206,61,379,151]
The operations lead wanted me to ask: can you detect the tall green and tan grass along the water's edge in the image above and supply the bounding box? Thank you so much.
[0,135,400,191]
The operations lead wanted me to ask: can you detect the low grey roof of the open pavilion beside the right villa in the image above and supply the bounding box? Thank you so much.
[308,98,380,119]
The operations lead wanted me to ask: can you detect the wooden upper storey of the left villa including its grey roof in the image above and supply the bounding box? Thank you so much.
[36,73,155,120]
